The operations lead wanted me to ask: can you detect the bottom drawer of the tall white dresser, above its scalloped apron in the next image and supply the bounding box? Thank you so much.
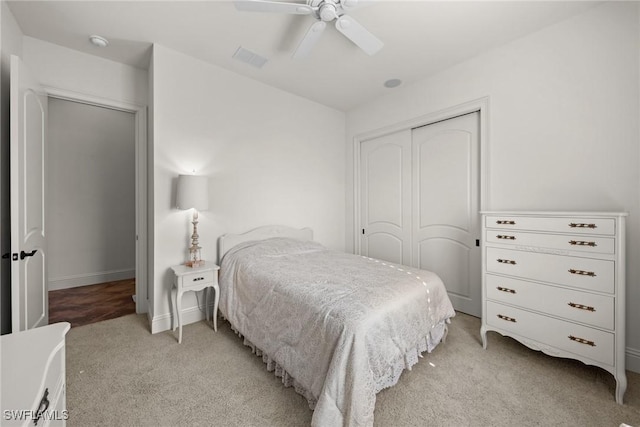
[486,301,615,365]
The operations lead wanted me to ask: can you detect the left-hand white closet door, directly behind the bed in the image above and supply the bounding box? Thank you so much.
[360,129,411,265]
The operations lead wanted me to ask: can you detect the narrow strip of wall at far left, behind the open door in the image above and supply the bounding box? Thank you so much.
[0,0,22,334]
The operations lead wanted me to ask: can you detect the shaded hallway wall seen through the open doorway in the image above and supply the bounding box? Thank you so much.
[46,98,136,290]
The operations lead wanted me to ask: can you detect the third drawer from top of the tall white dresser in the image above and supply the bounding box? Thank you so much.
[486,247,615,294]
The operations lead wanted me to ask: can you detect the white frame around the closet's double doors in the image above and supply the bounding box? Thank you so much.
[352,97,490,255]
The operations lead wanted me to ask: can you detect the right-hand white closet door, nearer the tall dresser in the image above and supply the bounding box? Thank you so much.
[412,112,481,316]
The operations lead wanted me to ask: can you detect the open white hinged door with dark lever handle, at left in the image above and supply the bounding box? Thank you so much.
[10,56,49,332]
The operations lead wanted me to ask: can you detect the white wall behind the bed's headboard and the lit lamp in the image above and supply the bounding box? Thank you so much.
[152,45,345,332]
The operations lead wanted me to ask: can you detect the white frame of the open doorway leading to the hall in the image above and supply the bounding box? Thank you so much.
[44,86,148,314]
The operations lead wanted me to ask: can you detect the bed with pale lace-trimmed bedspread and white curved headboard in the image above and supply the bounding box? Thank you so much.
[218,226,455,426]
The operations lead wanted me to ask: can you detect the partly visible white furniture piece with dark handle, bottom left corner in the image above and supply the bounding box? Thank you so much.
[0,322,70,427]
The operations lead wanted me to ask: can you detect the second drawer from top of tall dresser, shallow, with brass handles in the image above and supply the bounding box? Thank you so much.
[485,230,615,254]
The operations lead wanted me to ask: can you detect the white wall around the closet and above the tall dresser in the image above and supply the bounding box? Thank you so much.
[346,2,640,371]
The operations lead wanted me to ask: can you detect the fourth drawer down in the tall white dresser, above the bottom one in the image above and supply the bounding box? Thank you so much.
[485,274,615,330]
